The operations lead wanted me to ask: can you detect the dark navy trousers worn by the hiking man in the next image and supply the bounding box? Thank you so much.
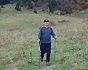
[40,42,51,62]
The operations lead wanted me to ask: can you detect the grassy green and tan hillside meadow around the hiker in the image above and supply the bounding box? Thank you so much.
[0,4,88,70]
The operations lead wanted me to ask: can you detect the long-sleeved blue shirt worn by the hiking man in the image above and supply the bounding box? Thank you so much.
[38,27,55,43]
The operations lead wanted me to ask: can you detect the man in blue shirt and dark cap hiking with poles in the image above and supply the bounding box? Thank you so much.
[38,19,57,66]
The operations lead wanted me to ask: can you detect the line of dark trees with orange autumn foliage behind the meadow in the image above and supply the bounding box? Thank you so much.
[0,0,88,15]
